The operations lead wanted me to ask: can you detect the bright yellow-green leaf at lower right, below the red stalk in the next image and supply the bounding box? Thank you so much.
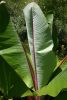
[37,69,67,97]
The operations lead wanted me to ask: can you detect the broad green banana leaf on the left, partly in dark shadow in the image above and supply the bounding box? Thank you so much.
[0,2,33,96]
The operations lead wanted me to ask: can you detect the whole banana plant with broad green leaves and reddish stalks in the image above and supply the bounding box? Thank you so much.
[0,1,67,100]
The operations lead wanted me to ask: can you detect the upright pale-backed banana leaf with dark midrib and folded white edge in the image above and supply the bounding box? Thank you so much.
[23,2,56,88]
